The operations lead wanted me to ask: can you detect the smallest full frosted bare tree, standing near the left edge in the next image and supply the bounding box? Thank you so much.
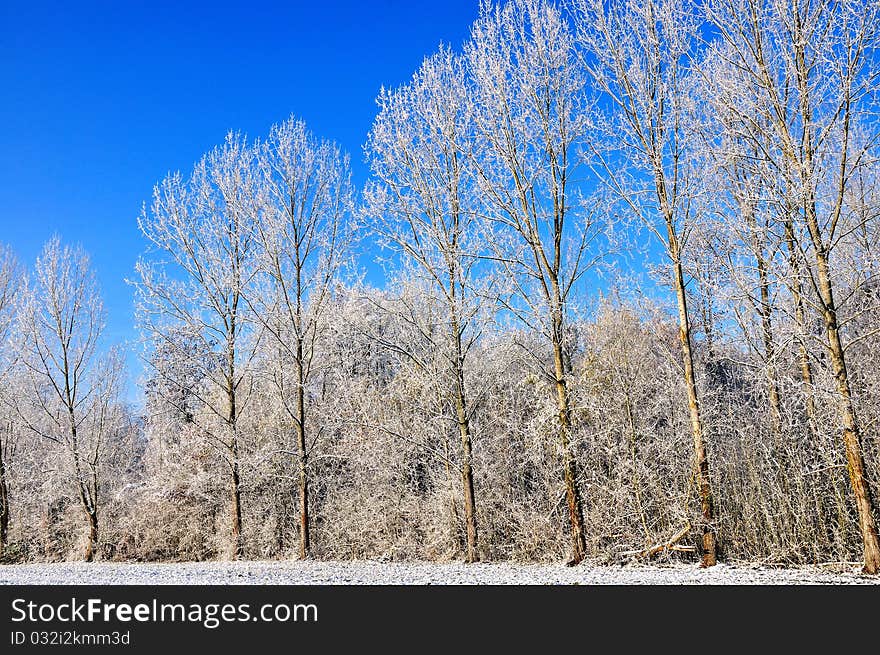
[20,237,121,562]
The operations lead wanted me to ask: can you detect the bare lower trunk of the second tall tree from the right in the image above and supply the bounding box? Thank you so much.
[667,231,717,567]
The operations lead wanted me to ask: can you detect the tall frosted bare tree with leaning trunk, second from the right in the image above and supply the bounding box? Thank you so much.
[573,0,717,566]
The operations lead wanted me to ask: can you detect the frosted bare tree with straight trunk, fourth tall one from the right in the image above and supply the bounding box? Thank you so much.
[365,48,486,562]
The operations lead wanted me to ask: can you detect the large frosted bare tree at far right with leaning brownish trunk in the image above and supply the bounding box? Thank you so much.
[708,0,880,573]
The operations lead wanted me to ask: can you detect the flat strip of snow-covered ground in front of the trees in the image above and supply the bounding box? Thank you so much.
[0,561,880,585]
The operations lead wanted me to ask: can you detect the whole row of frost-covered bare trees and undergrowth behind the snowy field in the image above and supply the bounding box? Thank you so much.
[0,0,880,573]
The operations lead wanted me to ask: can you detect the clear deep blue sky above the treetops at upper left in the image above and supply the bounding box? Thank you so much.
[0,0,478,397]
